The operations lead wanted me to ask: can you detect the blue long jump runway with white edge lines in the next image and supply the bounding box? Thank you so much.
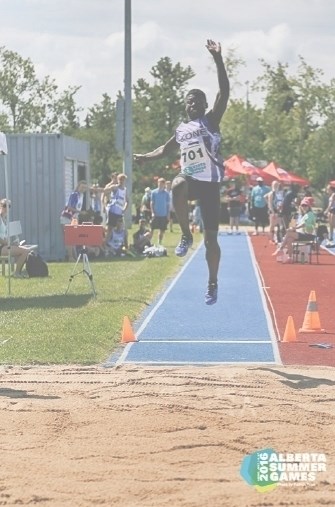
[116,233,280,365]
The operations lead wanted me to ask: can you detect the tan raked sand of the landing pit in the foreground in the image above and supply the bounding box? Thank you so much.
[0,365,335,507]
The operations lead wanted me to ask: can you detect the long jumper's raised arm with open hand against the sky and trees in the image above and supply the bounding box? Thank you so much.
[206,39,229,124]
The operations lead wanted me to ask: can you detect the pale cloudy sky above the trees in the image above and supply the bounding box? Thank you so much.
[0,0,335,116]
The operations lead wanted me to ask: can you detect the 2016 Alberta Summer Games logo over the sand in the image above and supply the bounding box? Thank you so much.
[241,449,327,493]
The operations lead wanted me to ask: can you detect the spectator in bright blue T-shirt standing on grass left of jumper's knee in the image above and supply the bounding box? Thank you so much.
[151,178,170,245]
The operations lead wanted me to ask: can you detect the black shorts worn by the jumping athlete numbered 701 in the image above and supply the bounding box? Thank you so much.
[178,174,221,231]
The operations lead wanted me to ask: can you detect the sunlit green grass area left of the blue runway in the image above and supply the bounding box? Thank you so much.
[0,227,202,365]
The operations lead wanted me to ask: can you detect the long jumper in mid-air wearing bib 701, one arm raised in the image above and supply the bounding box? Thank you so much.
[134,39,229,305]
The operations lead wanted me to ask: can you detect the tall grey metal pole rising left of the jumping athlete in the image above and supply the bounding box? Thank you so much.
[123,0,133,228]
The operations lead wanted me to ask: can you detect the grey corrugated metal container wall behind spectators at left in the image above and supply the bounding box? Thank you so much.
[0,134,90,261]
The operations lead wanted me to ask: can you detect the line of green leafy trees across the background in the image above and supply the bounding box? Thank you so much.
[0,47,335,201]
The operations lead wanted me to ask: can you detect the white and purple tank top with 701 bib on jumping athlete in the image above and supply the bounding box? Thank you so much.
[176,113,223,182]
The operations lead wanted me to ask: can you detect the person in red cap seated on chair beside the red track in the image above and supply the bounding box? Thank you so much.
[272,197,316,262]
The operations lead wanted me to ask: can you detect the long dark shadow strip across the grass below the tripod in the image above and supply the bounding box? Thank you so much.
[0,294,92,311]
